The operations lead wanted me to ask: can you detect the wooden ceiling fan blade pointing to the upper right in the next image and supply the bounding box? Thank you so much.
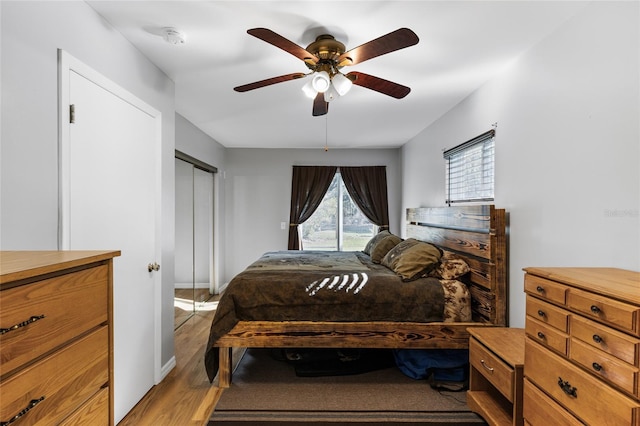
[336,28,419,67]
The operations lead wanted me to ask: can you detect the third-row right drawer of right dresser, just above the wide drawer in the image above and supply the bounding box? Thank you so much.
[571,339,638,396]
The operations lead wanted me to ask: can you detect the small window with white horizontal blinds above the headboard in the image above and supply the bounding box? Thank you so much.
[444,130,495,204]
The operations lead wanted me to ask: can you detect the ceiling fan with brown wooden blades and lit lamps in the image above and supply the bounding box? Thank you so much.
[233,28,418,116]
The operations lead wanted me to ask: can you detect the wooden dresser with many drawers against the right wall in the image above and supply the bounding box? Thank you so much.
[524,268,640,426]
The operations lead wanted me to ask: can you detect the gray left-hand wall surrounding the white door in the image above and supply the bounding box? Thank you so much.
[0,1,175,365]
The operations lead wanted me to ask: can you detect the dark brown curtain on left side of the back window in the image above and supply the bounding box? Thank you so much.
[288,166,337,250]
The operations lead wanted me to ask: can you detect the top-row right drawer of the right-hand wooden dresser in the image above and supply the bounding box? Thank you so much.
[567,288,640,336]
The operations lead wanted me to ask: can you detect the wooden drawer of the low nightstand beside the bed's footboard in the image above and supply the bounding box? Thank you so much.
[469,338,514,402]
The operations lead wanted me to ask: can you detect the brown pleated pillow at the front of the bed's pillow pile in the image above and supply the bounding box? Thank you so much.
[381,238,442,281]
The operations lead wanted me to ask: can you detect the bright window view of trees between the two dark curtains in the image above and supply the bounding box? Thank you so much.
[300,173,376,251]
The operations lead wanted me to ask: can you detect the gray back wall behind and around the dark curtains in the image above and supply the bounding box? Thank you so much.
[223,149,402,282]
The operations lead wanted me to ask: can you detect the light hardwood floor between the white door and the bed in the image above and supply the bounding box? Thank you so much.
[118,302,222,426]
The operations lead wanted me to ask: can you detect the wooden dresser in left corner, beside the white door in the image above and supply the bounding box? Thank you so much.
[0,251,120,426]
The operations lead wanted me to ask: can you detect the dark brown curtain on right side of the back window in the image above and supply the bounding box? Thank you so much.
[340,166,389,231]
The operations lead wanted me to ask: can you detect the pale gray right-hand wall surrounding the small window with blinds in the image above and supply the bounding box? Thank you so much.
[402,2,640,327]
